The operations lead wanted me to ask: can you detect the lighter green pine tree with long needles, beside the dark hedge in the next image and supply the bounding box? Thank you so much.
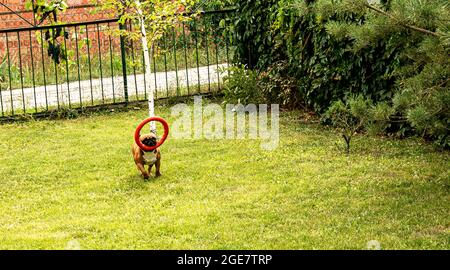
[312,0,450,147]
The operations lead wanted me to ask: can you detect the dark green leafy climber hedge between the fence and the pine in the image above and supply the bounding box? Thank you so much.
[233,0,398,112]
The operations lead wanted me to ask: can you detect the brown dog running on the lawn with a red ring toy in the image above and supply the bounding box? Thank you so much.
[131,133,161,180]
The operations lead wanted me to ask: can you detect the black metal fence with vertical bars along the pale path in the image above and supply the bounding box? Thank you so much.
[0,10,234,119]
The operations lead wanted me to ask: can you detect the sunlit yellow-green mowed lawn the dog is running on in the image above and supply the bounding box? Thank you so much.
[0,99,450,249]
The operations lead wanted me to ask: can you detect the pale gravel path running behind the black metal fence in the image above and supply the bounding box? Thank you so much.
[0,64,227,113]
